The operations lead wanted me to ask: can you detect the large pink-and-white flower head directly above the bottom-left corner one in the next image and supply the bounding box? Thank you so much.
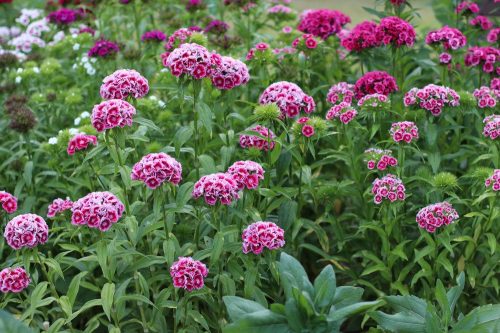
[3,214,49,250]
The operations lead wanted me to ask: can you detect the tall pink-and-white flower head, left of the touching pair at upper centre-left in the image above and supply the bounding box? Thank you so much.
[162,43,220,79]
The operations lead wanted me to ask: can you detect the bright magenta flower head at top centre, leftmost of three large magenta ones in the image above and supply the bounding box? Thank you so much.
[298,9,351,39]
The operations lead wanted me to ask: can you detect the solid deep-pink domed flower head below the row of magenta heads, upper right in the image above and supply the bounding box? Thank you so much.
[354,71,399,99]
